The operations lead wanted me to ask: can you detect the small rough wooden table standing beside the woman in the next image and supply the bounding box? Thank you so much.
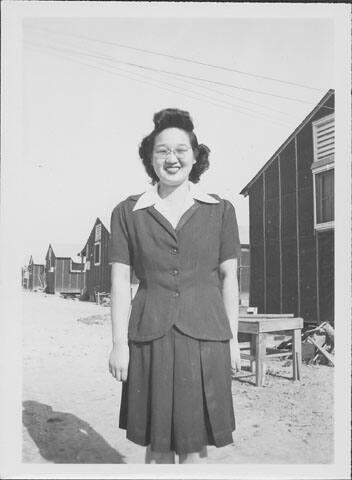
[238,314,303,386]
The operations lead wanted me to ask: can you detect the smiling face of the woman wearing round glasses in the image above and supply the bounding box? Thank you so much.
[152,128,196,186]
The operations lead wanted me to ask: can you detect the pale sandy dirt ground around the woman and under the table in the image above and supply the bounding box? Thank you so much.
[23,292,334,464]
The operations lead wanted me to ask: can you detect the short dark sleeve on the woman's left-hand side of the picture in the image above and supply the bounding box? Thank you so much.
[109,203,132,265]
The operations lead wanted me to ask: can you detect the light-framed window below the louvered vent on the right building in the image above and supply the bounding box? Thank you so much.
[313,165,334,230]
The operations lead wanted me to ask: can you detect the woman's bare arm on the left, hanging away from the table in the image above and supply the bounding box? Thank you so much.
[109,262,131,381]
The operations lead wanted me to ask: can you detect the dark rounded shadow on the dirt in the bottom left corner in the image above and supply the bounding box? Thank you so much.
[22,400,125,463]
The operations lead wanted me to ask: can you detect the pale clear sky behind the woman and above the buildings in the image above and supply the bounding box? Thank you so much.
[21,16,334,263]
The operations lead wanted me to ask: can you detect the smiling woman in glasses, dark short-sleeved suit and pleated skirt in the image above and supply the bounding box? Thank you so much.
[109,109,240,463]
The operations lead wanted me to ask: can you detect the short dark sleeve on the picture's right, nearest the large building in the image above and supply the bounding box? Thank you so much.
[219,200,241,263]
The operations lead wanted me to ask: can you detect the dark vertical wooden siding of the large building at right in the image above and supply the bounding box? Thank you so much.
[242,92,334,322]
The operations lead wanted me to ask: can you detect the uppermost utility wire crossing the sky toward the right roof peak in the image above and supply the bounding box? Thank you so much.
[26,27,322,91]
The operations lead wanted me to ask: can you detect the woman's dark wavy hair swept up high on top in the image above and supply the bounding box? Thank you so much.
[139,108,210,184]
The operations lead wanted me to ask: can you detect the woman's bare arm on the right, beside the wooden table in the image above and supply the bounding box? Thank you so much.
[219,258,241,371]
